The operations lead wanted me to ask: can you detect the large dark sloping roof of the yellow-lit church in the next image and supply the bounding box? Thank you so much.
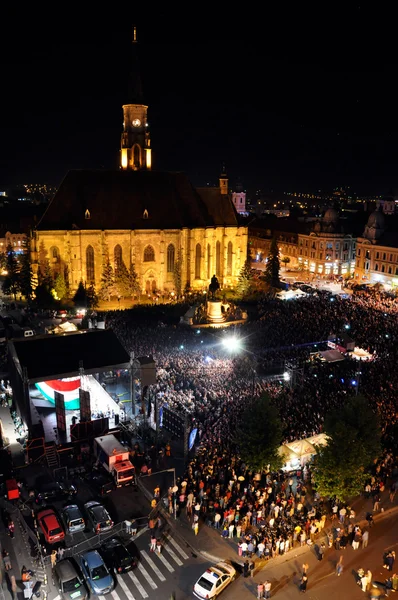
[36,170,238,231]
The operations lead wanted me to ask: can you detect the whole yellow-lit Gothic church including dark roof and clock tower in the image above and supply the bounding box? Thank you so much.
[31,29,248,293]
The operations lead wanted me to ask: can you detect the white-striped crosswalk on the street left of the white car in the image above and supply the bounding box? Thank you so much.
[51,534,189,600]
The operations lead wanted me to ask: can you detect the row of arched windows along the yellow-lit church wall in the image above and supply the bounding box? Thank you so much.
[50,242,233,283]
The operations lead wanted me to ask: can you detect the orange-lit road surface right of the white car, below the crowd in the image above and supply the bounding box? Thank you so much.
[219,516,398,600]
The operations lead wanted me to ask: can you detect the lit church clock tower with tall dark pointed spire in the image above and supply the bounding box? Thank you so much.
[120,27,152,171]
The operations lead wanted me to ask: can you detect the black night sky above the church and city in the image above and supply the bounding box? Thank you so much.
[0,9,398,194]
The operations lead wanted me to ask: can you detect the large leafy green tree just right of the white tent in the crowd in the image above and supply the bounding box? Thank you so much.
[314,396,381,502]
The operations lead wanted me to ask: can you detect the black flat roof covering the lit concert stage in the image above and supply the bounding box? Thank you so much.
[9,329,130,383]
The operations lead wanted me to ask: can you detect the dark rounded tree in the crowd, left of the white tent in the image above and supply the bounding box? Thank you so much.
[235,394,282,472]
